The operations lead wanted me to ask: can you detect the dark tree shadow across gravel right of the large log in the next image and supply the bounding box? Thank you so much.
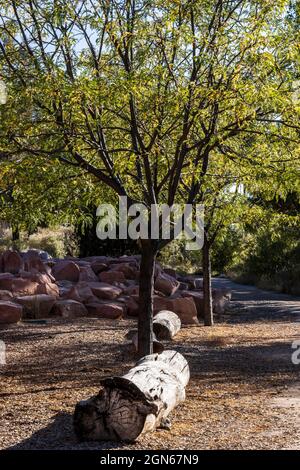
[175,336,300,390]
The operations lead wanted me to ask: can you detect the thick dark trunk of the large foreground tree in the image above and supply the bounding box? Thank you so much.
[138,240,157,357]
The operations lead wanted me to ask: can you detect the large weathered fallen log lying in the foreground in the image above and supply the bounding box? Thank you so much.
[74,351,190,442]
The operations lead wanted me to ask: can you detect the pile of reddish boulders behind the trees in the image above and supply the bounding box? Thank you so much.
[0,250,230,324]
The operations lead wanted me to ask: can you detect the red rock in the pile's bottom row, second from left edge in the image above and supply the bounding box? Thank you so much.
[16,294,56,318]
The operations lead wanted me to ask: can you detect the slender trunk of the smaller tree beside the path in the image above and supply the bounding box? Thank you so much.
[202,232,214,326]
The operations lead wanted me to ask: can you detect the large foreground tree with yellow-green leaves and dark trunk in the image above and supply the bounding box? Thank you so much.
[0,0,299,355]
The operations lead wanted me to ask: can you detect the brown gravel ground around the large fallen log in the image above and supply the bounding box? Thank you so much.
[0,279,300,449]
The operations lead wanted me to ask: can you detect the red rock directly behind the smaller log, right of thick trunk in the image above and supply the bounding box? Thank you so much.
[153,296,199,325]
